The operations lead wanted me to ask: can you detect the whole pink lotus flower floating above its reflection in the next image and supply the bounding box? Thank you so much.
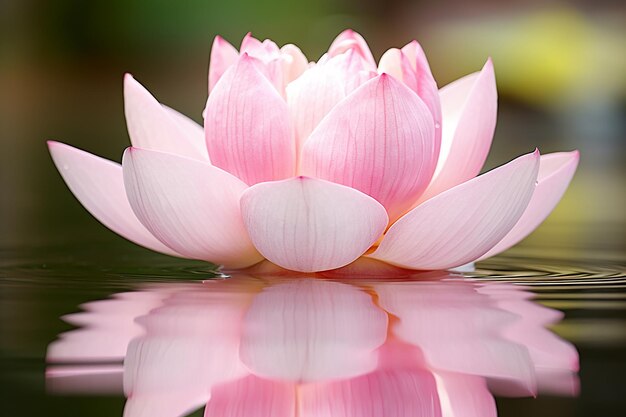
[49,30,578,272]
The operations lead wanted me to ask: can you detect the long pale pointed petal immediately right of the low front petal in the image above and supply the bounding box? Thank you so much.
[369,151,539,269]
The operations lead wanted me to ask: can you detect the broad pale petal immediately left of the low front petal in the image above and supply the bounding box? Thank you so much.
[122,148,262,268]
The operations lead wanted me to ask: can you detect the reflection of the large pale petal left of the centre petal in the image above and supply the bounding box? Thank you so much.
[124,283,254,417]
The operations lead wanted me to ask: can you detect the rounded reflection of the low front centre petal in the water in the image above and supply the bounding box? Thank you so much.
[240,278,387,382]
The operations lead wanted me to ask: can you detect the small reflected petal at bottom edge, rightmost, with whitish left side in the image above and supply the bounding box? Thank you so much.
[435,372,498,417]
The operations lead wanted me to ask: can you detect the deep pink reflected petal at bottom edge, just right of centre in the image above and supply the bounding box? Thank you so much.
[298,369,442,417]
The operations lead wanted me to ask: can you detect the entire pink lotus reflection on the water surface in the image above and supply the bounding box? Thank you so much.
[47,264,578,417]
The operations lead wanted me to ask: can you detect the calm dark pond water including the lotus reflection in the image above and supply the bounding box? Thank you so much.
[0,227,626,417]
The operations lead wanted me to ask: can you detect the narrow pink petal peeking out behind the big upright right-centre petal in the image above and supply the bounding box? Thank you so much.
[378,41,442,145]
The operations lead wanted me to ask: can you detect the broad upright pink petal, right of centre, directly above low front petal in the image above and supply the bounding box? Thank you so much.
[301,74,438,221]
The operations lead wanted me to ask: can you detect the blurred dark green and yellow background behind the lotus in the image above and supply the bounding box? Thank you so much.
[0,0,626,247]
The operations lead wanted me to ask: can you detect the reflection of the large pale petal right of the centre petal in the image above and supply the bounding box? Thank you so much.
[375,282,536,395]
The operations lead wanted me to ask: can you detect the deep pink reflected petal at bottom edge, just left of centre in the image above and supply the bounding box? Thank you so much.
[204,375,296,417]
